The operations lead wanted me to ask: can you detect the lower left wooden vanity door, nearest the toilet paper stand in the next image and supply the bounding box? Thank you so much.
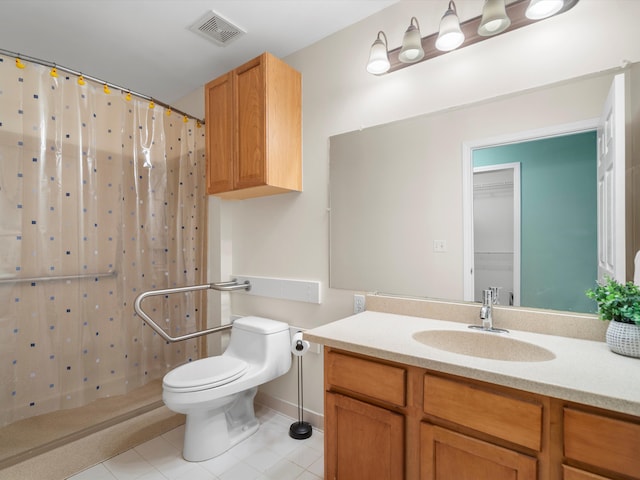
[325,392,404,480]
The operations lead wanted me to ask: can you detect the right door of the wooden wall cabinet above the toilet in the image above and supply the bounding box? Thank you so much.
[234,56,267,189]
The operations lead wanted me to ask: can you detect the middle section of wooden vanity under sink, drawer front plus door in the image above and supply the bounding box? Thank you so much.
[420,373,544,480]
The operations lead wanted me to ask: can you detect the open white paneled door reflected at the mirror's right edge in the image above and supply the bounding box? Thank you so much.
[598,74,626,282]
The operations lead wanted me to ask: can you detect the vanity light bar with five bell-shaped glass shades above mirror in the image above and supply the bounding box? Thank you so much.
[367,0,580,75]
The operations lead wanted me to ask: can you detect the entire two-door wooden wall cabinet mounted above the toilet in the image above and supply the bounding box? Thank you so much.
[205,53,302,199]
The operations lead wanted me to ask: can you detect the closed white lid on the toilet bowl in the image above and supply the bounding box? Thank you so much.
[162,355,247,392]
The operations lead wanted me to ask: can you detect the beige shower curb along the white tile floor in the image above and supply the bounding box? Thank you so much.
[0,406,184,480]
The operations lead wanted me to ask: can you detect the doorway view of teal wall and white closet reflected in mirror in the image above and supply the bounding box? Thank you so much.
[471,130,598,312]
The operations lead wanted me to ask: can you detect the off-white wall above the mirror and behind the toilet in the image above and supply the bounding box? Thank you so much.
[178,0,640,420]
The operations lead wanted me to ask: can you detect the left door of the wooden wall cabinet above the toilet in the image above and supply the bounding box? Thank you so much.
[205,73,235,194]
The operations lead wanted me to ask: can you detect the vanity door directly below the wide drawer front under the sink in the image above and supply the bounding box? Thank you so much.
[420,423,537,480]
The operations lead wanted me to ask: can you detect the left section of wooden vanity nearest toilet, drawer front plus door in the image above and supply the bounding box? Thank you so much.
[325,350,407,480]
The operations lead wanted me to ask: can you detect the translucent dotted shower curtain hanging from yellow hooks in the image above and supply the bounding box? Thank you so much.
[0,56,206,426]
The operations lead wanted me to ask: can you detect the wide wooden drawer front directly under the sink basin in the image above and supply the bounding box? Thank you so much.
[423,374,543,451]
